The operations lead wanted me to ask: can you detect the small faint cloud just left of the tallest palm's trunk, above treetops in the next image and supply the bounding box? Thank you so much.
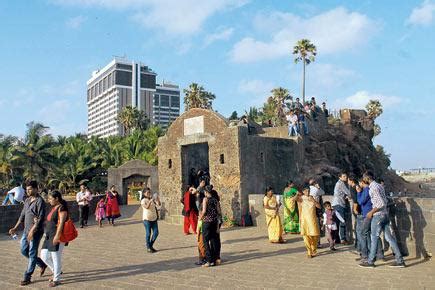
[238,80,275,106]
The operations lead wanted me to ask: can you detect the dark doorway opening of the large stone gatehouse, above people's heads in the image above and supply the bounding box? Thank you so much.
[181,143,210,190]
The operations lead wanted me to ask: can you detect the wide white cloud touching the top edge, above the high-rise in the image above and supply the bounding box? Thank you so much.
[53,0,248,35]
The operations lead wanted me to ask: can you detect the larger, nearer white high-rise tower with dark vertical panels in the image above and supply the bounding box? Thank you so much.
[87,58,179,137]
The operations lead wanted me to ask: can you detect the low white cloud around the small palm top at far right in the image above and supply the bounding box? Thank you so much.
[339,91,404,109]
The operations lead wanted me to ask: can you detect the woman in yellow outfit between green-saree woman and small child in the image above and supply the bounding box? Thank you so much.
[293,187,321,258]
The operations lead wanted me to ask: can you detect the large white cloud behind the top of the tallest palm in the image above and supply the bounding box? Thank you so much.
[230,7,378,62]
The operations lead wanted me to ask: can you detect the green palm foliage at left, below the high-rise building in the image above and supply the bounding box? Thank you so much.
[0,123,163,192]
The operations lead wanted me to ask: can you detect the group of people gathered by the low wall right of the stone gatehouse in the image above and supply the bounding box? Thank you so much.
[263,171,405,268]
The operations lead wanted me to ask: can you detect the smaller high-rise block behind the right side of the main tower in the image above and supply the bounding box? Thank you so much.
[153,82,180,128]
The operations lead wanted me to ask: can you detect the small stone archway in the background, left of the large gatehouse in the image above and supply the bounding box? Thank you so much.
[107,160,159,204]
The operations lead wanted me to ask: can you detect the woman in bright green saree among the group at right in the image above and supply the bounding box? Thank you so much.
[283,181,299,234]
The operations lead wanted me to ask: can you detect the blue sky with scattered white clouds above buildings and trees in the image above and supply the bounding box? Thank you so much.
[0,0,435,169]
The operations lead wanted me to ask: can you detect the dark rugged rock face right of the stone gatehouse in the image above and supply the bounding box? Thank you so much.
[299,110,404,193]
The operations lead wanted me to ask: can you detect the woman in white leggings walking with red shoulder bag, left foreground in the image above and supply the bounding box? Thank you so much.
[41,190,68,287]
